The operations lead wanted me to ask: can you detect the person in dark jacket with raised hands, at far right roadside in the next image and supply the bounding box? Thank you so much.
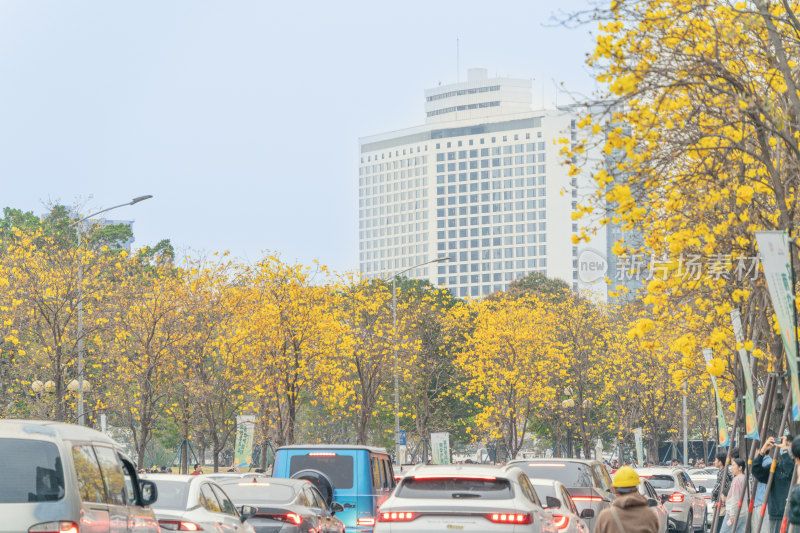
[753,435,794,533]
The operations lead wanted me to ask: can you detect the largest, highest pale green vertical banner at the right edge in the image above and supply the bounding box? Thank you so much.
[756,231,800,420]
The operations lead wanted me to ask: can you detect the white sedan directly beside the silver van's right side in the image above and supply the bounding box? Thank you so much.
[142,474,255,533]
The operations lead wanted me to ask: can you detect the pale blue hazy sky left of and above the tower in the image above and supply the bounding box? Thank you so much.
[0,0,595,271]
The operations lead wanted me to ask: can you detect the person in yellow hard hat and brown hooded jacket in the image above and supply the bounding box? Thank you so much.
[594,466,658,533]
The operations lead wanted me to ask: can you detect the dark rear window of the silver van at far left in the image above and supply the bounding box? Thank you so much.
[0,439,64,504]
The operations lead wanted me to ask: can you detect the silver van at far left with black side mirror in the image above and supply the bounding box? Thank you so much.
[0,420,159,533]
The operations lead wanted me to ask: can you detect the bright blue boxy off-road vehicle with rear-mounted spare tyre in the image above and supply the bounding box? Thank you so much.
[272,444,395,533]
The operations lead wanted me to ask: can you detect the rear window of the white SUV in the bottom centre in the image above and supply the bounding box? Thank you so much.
[396,476,514,500]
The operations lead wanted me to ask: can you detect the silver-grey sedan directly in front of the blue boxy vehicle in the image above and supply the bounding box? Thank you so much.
[220,479,345,533]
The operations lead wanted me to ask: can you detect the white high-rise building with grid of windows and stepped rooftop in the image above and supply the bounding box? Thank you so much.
[359,69,613,299]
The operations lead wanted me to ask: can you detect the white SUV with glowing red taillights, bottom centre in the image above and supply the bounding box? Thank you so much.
[374,464,558,533]
